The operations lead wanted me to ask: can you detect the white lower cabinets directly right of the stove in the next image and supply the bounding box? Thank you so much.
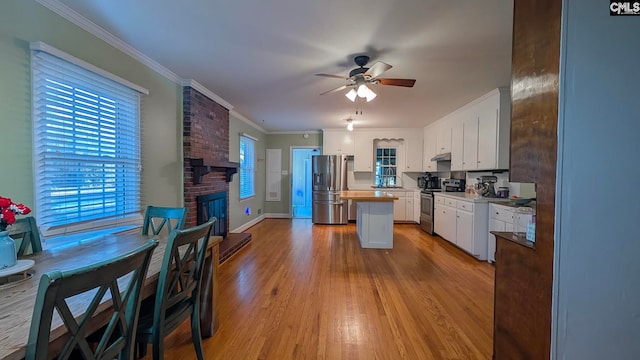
[434,194,489,260]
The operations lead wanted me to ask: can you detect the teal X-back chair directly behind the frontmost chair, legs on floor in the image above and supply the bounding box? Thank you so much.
[136,217,216,360]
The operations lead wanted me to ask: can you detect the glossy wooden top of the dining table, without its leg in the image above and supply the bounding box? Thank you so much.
[0,230,221,359]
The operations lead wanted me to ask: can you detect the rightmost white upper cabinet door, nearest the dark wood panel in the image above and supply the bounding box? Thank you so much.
[477,98,499,170]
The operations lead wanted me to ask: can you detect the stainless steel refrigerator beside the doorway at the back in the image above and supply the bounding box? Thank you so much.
[311,155,349,224]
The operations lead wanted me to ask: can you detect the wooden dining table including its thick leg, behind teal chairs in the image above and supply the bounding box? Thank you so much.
[0,229,222,360]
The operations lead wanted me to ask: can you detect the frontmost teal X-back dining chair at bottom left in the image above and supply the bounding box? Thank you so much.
[26,239,158,360]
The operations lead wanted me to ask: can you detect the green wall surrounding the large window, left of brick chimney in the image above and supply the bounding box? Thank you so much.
[0,0,183,218]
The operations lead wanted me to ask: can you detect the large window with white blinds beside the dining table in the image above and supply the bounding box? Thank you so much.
[31,43,146,236]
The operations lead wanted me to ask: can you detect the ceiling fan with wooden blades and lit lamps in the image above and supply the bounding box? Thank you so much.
[316,55,416,102]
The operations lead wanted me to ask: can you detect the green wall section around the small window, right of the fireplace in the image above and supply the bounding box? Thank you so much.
[229,112,267,231]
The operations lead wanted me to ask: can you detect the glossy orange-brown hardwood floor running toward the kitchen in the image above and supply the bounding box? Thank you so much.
[152,219,494,360]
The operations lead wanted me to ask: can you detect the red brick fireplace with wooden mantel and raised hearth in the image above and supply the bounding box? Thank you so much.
[182,86,251,262]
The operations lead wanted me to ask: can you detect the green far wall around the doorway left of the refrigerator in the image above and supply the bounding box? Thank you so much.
[265,133,322,214]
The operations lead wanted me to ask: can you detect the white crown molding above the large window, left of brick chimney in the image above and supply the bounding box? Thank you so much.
[36,0,182,84]
